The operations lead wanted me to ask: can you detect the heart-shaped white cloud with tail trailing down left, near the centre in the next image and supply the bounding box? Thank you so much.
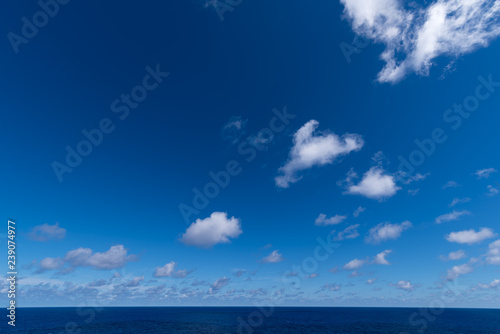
[275,120,364,188]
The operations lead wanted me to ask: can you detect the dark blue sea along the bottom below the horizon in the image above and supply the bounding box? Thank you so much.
[0,307,500,334]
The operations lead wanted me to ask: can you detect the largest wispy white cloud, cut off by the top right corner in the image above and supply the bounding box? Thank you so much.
[341,0,500,83]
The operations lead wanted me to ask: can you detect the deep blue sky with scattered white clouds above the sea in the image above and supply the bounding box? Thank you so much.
[0,0,500,307]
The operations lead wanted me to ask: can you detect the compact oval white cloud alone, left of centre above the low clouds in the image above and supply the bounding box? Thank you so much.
[180,212,243,248]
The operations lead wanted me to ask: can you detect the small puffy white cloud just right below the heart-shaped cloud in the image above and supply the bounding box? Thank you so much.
[346,166,401,200]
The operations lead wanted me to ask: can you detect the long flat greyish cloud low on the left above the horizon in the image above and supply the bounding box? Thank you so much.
[37,245,137,273]
